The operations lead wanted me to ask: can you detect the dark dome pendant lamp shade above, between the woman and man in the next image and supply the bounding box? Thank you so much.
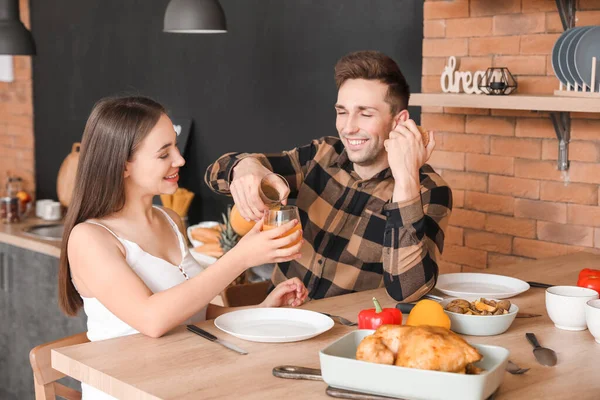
[163,0,227,33]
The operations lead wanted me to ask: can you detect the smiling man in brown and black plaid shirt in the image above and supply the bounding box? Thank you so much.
[205,51,452,301]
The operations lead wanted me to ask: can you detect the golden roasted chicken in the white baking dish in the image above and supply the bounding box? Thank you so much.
[356,325,482,374]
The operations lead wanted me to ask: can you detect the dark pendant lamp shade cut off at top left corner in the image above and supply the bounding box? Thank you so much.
[0,0,35,55]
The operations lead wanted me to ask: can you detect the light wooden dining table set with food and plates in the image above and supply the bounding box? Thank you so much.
[52,253,600,400]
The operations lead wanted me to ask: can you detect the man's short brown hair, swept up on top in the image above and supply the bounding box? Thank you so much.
[334,51,410,115]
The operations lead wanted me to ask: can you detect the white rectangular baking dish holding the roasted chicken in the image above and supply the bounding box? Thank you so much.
[319,330,509,400]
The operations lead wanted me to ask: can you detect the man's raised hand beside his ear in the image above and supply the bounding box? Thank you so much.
[384,119,435,202]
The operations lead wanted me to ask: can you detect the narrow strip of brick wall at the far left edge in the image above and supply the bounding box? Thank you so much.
[0,0,35,195]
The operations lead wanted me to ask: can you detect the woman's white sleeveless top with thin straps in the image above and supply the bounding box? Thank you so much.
[81,207,206,400]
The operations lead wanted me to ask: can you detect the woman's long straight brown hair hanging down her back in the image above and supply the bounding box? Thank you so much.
[58,97,166,316]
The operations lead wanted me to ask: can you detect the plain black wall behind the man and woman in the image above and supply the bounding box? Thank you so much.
[31,0,423,223]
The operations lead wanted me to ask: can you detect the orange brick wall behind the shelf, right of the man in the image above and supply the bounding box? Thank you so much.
[421,0,600,272]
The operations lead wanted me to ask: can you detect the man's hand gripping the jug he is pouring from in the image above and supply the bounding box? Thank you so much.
[229,157,289,221]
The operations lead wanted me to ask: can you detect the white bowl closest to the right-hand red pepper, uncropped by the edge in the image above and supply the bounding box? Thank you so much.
[546,286,598,331]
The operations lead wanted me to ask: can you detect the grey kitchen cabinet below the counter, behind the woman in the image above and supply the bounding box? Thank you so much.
[0,243,86,400]
